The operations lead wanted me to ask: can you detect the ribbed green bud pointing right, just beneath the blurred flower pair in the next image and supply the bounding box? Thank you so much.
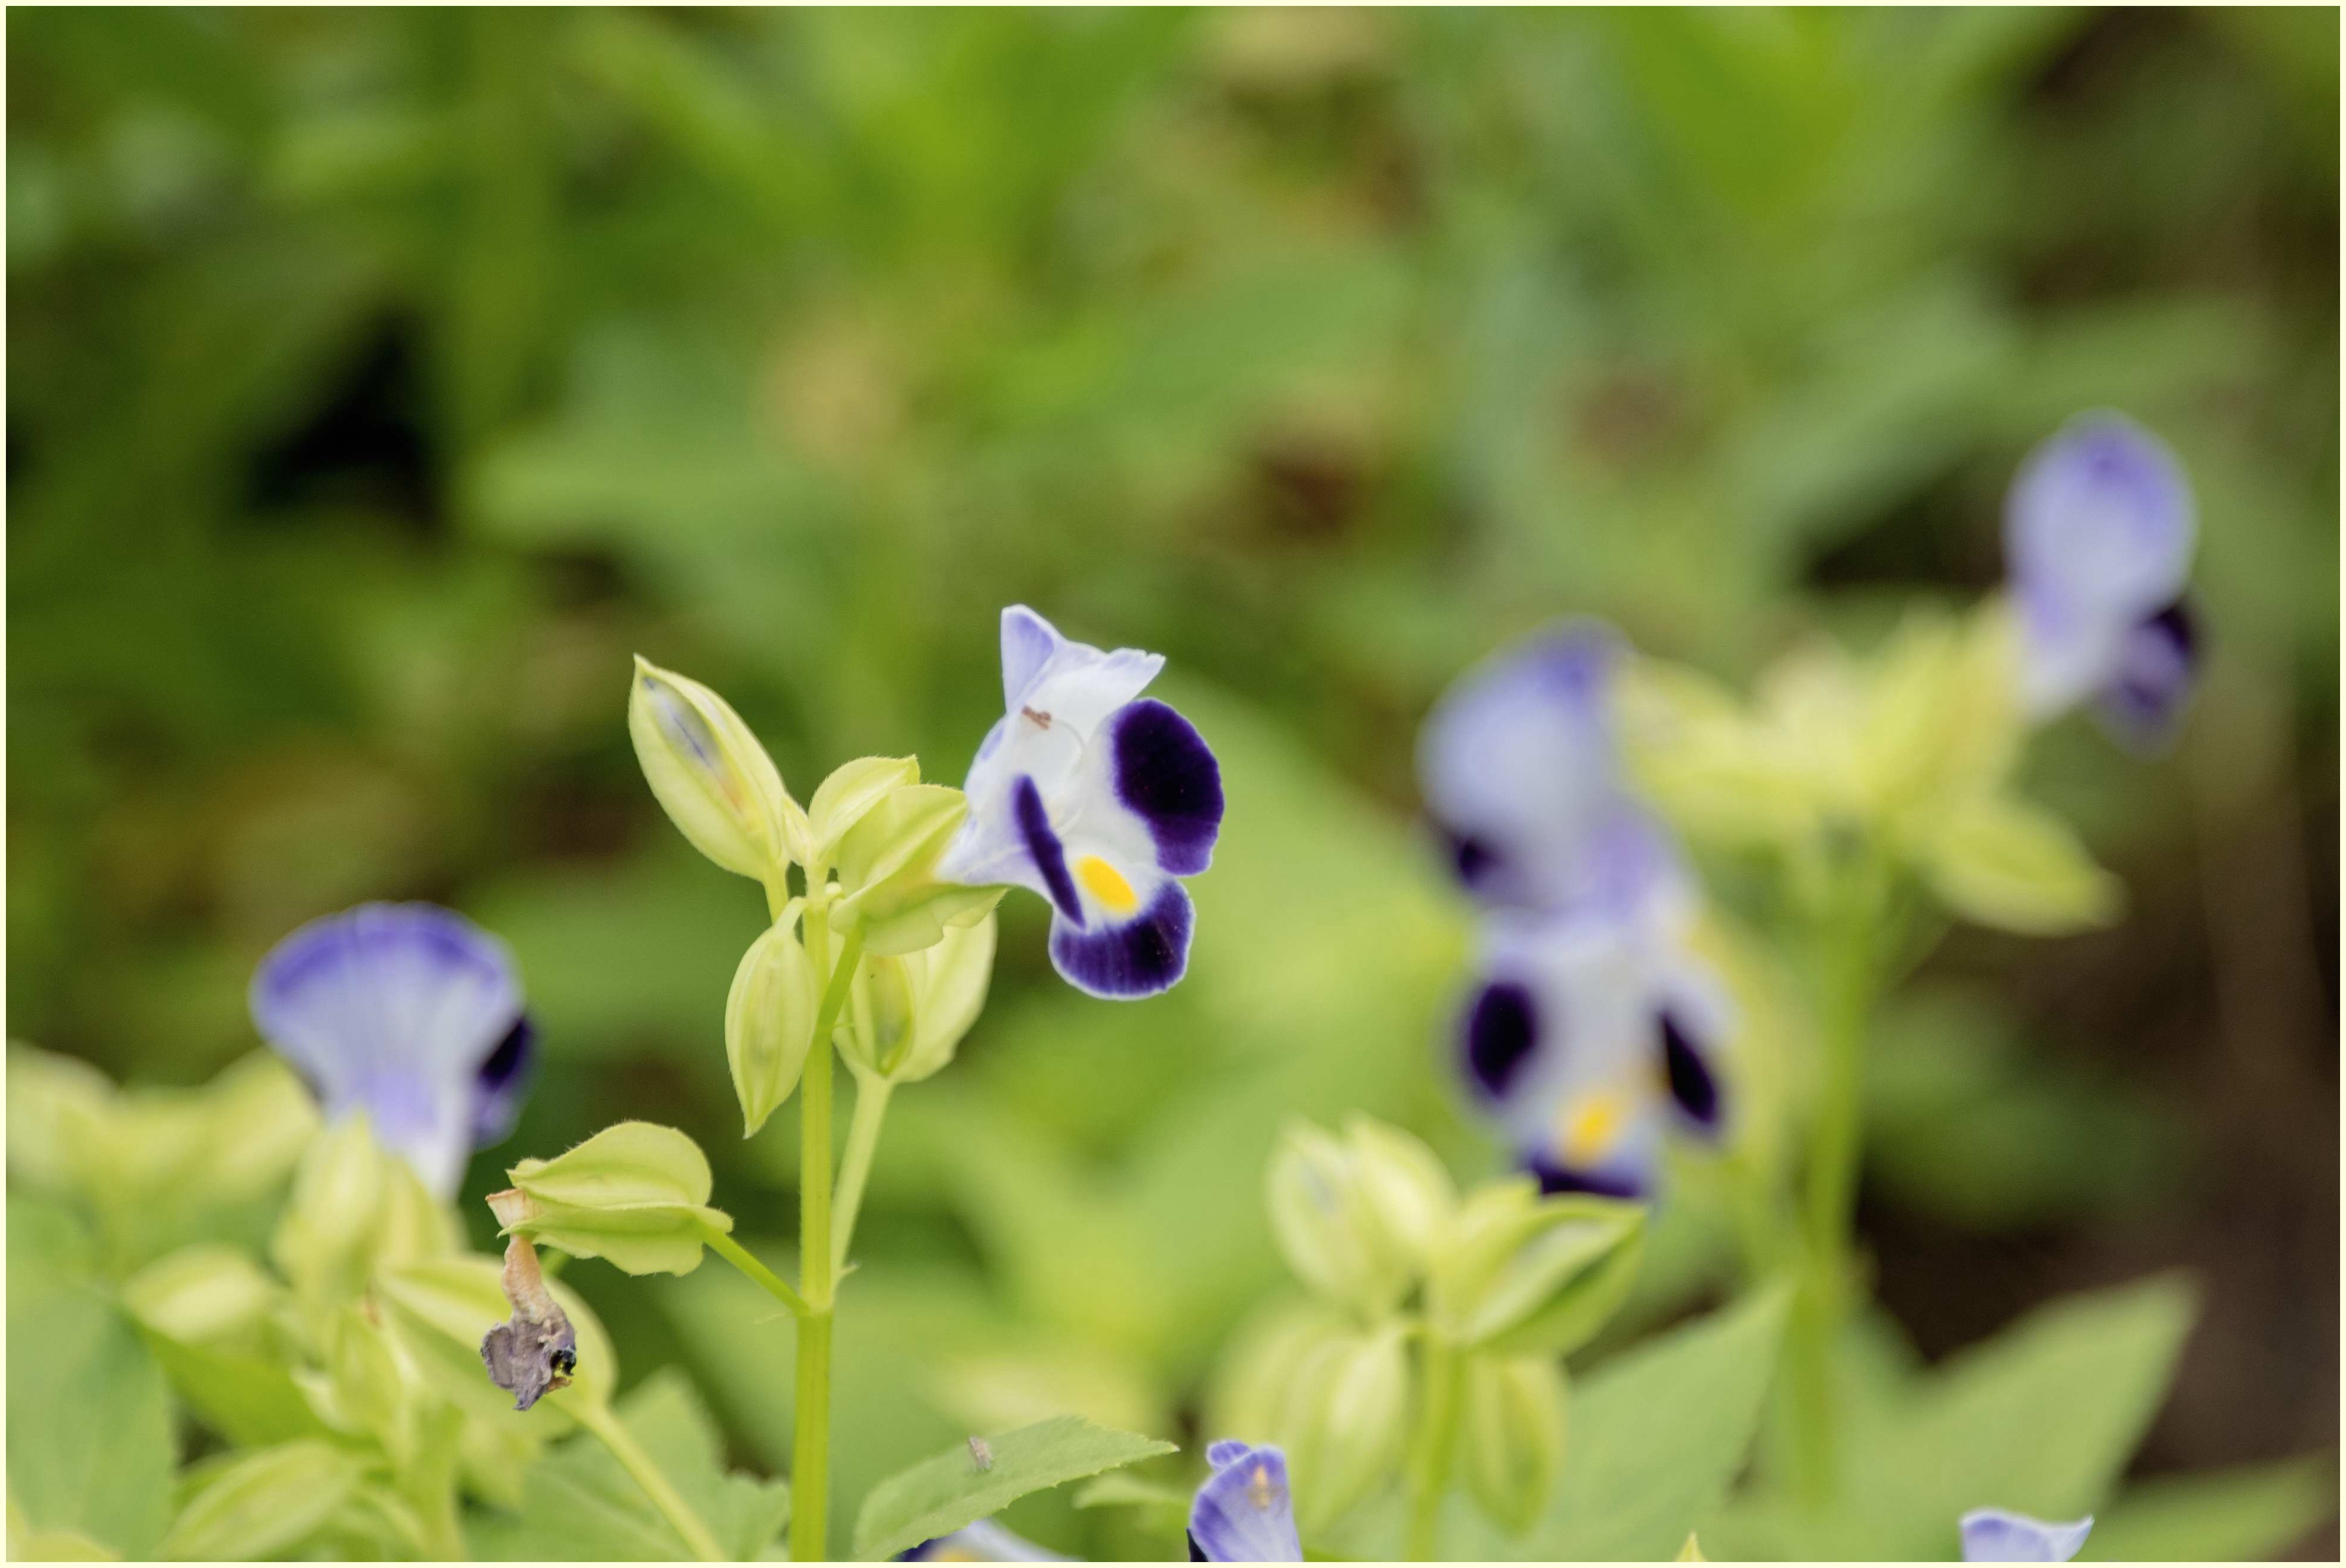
[1426,1181,1644,1355]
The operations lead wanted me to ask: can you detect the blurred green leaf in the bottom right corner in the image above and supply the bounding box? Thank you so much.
[2079,1453,2339,1563]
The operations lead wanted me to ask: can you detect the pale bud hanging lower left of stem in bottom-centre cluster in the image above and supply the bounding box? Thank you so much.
[1276,1321,1410,1535]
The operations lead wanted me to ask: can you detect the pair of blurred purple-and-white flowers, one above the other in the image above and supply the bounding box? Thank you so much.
[1417,622,1732,1197]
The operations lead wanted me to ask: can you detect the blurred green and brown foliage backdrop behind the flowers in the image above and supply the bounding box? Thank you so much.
[7,9,2339,1554]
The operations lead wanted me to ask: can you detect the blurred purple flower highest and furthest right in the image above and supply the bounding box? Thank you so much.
[2003,413,2198,747]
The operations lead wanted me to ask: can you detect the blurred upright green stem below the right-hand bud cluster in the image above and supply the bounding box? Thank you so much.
[1786,859,1884,1505]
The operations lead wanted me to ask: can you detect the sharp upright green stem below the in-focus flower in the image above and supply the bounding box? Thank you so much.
[791,887,863,1563]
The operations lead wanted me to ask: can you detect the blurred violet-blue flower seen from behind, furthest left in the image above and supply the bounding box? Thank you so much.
[248,904,533,1197]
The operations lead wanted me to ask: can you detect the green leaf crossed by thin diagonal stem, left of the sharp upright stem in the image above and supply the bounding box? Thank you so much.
[471,1369,791,1561]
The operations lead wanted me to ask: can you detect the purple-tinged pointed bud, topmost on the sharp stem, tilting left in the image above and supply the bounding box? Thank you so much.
[626,657,807,882]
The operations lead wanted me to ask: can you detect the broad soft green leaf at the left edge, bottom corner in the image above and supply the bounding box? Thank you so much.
[7,1197,174,1556]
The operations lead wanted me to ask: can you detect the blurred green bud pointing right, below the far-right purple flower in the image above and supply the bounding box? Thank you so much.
[1921,796,2123,936]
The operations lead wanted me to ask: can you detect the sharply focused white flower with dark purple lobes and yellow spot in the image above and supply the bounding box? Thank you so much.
[936,605,1222,997]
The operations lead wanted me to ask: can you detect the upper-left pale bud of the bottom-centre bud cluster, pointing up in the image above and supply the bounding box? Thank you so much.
[1267,1122,1445,1317]
